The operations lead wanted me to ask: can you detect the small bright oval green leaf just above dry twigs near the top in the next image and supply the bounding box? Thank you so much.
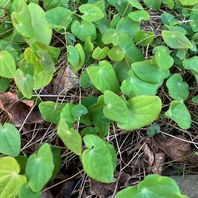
[128,10,150,22]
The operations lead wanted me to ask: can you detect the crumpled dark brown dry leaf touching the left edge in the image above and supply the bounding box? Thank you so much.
[0,92,43,127]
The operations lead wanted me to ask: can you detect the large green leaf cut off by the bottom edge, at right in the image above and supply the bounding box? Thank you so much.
[115,174,188,198]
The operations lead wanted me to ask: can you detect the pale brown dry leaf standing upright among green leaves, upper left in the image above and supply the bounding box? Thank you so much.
[52,67,79,94]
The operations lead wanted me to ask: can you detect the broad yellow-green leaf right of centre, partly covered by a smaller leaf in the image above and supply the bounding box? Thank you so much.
[118,96,162,130]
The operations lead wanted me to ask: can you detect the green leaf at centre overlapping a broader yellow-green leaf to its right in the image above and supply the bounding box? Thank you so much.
[103,91,129,123]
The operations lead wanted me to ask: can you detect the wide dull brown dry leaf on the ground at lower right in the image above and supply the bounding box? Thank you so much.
[153,135,191,161]
